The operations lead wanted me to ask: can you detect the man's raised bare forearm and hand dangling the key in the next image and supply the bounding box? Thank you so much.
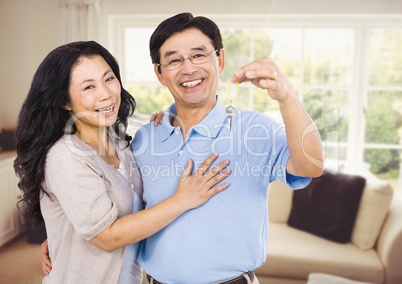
[232,57,324,177]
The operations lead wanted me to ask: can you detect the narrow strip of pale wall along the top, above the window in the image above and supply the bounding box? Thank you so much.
[102,0,402,15]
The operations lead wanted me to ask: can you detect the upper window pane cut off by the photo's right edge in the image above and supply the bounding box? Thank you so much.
[369,29,402,86]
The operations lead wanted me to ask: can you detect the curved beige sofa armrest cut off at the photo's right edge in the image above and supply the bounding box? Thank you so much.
[377,193,402,284]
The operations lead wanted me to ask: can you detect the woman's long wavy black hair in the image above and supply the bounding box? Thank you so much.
[14,41,135,225]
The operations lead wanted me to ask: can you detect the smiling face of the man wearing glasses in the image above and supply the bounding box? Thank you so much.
[155,29,224,111]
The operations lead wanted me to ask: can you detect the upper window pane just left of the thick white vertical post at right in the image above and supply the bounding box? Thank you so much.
[304,28,355,85]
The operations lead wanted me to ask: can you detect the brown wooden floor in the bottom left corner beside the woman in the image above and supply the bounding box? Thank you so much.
[0,235,44,284]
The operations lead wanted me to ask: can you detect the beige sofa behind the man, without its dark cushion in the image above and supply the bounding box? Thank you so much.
[256,171,402,284]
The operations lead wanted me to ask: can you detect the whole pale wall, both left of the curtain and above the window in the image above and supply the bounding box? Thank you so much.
[0,0,402,127]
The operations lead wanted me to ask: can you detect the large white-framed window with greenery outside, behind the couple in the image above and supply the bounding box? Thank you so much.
[111,15,402,189]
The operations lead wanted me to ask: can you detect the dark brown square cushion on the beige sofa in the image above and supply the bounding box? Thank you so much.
[288,171,366,243]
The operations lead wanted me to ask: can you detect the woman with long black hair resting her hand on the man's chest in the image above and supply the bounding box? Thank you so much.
[14,41,229,283]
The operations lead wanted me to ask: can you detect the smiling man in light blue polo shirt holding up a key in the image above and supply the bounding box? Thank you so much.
[132,13,323,284]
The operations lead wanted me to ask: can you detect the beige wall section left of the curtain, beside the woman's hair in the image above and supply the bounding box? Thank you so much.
[0,0,61,127]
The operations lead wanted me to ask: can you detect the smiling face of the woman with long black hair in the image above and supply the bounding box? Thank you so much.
[65,55,121,131]
